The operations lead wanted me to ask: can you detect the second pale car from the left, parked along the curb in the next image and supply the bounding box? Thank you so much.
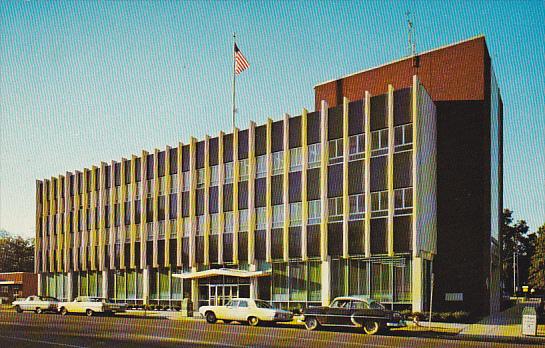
[57,296,127,317]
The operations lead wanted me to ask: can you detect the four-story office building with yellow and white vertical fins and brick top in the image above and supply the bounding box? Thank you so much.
[36,38,501,316]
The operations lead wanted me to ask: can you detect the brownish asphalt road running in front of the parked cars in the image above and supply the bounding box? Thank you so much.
[0,312,536,348]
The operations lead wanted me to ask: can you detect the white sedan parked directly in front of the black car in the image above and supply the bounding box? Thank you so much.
[199,298,293,326]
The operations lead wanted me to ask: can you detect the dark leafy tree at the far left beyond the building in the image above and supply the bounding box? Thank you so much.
[0,236,34,273]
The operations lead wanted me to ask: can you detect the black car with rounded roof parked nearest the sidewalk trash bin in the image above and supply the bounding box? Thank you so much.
[301,296,407,335]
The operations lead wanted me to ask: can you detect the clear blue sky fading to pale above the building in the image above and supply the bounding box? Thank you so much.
[0,0,545,237]
